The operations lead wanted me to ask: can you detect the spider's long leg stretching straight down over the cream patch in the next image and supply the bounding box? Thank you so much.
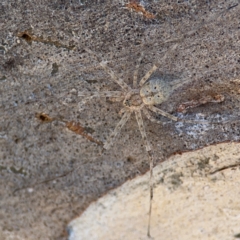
[135,111,153,237]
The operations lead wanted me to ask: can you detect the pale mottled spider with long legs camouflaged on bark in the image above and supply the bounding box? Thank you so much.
[78,45,195,237]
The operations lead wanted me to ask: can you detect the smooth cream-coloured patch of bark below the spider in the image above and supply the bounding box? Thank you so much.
[69,143,240,240]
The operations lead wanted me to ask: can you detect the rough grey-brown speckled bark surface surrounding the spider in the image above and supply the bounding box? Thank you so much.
[0,0,240,240]
